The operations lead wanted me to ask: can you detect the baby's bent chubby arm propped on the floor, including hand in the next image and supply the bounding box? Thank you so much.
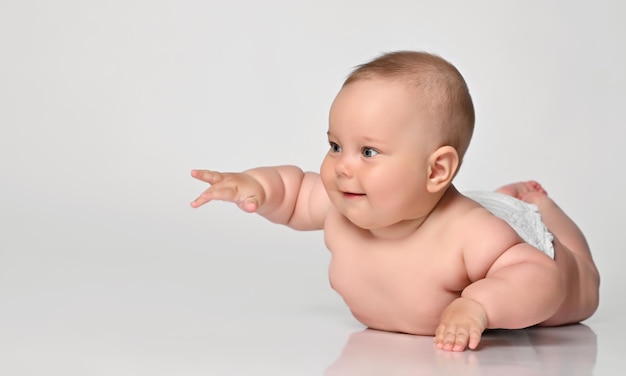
[435,217,565,351]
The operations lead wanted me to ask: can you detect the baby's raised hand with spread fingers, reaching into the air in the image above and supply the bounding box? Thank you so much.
[191,170,265,213]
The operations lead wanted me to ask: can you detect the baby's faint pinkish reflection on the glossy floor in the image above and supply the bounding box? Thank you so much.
[325,324,597,376]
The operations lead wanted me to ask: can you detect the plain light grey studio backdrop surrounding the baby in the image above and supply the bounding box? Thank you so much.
[0,0,626,375]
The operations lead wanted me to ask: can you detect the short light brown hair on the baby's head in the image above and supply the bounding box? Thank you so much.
[343,51,474,163]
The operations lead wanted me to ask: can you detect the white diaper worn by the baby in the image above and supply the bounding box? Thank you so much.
[464,191,554,259]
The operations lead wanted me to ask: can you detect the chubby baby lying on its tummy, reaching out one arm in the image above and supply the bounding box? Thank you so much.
[191,51,599,351]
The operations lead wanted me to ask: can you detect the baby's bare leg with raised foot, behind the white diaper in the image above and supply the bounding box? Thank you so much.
[497,181,600,325]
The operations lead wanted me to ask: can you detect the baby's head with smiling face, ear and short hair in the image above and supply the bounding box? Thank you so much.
[320,52,474,231]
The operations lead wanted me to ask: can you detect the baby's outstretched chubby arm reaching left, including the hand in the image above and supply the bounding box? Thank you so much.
[191,166,330,230]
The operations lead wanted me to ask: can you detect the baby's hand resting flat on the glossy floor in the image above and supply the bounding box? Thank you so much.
[435,298,487,351]
